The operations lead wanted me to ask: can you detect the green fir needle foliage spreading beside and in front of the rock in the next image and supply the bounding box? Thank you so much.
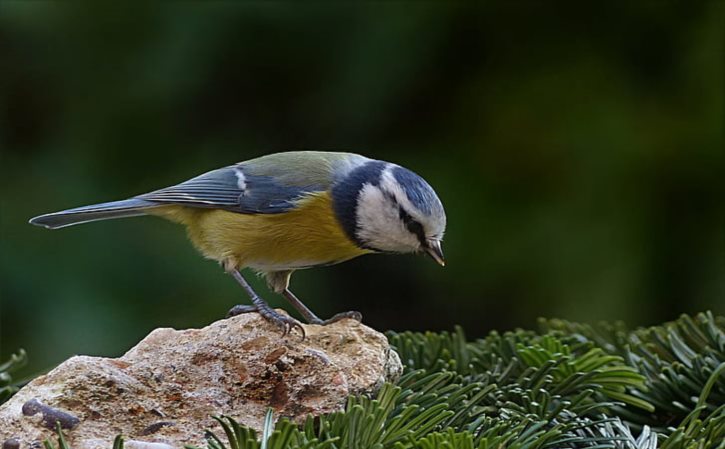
[46,313,725,449]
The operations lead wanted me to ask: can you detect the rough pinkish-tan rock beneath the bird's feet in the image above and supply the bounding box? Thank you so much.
[0,313,402,449]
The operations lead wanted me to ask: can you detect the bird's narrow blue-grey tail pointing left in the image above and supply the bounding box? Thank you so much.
[30,198,161,229]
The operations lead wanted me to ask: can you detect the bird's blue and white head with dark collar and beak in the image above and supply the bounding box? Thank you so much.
[333,161,446,265]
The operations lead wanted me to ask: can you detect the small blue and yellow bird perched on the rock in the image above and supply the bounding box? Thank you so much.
[30,151,446,338]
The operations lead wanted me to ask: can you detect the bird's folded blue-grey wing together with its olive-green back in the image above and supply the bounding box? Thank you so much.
[136,152,364,214]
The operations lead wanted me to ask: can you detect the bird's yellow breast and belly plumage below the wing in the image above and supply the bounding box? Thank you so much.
[154,192,372,271]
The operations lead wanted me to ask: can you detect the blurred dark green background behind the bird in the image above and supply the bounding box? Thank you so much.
[0,1,725,370]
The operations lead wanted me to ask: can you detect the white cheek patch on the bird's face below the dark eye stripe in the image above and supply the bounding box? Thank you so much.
[357,184,420,253]
